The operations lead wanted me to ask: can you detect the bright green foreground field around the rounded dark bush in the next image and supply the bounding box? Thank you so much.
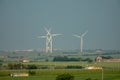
[0,69,120,80]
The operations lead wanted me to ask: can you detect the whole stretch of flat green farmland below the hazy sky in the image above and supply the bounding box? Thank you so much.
[0,51,120,80]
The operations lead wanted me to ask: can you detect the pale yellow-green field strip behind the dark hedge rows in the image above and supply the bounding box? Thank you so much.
[24,62,120,69]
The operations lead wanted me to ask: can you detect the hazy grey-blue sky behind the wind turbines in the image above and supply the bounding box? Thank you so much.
[0,0,120,50]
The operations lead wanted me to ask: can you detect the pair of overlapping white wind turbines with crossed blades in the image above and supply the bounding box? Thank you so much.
[38,28,61,53]
